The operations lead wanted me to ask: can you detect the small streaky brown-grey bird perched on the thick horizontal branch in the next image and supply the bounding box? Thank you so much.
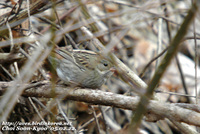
[48,48,115,89]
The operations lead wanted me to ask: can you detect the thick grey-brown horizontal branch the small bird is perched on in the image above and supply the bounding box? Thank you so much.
[0,81,200,126]
